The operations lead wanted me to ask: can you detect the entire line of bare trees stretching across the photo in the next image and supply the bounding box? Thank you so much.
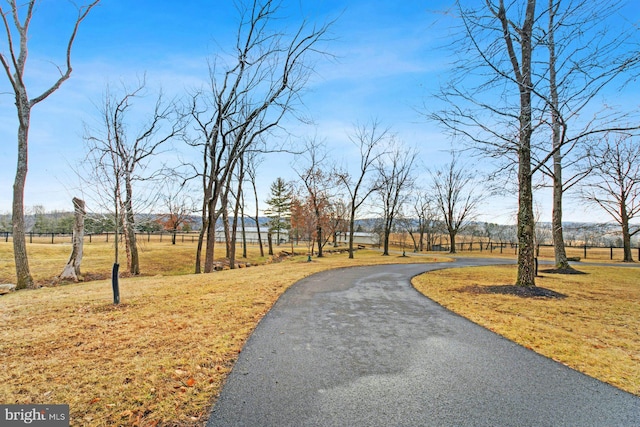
[0,0,640,288]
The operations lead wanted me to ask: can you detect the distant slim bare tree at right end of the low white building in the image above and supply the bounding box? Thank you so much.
[376,141,416,255]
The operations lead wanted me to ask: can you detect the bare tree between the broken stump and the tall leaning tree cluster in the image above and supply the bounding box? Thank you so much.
[85,80,185,274]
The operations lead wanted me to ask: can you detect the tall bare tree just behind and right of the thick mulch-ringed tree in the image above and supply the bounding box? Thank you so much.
[536,0,640,271]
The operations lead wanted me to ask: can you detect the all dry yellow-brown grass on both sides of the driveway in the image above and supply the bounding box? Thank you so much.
[0,239,640,426]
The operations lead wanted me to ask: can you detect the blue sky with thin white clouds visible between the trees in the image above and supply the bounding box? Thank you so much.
[0,0,638,226]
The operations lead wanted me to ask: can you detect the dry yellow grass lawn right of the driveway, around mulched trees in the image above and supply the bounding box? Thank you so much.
[414,265,640,396]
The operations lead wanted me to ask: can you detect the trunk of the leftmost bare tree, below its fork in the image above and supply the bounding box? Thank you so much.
[11,90,35,289]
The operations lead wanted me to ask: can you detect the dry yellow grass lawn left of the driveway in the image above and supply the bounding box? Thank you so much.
[0,243,445,427]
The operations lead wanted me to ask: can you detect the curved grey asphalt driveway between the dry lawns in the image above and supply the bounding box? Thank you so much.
[207,259,640,427]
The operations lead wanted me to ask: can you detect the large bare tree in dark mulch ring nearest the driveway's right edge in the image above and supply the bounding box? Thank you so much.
[430,0,545,286]
